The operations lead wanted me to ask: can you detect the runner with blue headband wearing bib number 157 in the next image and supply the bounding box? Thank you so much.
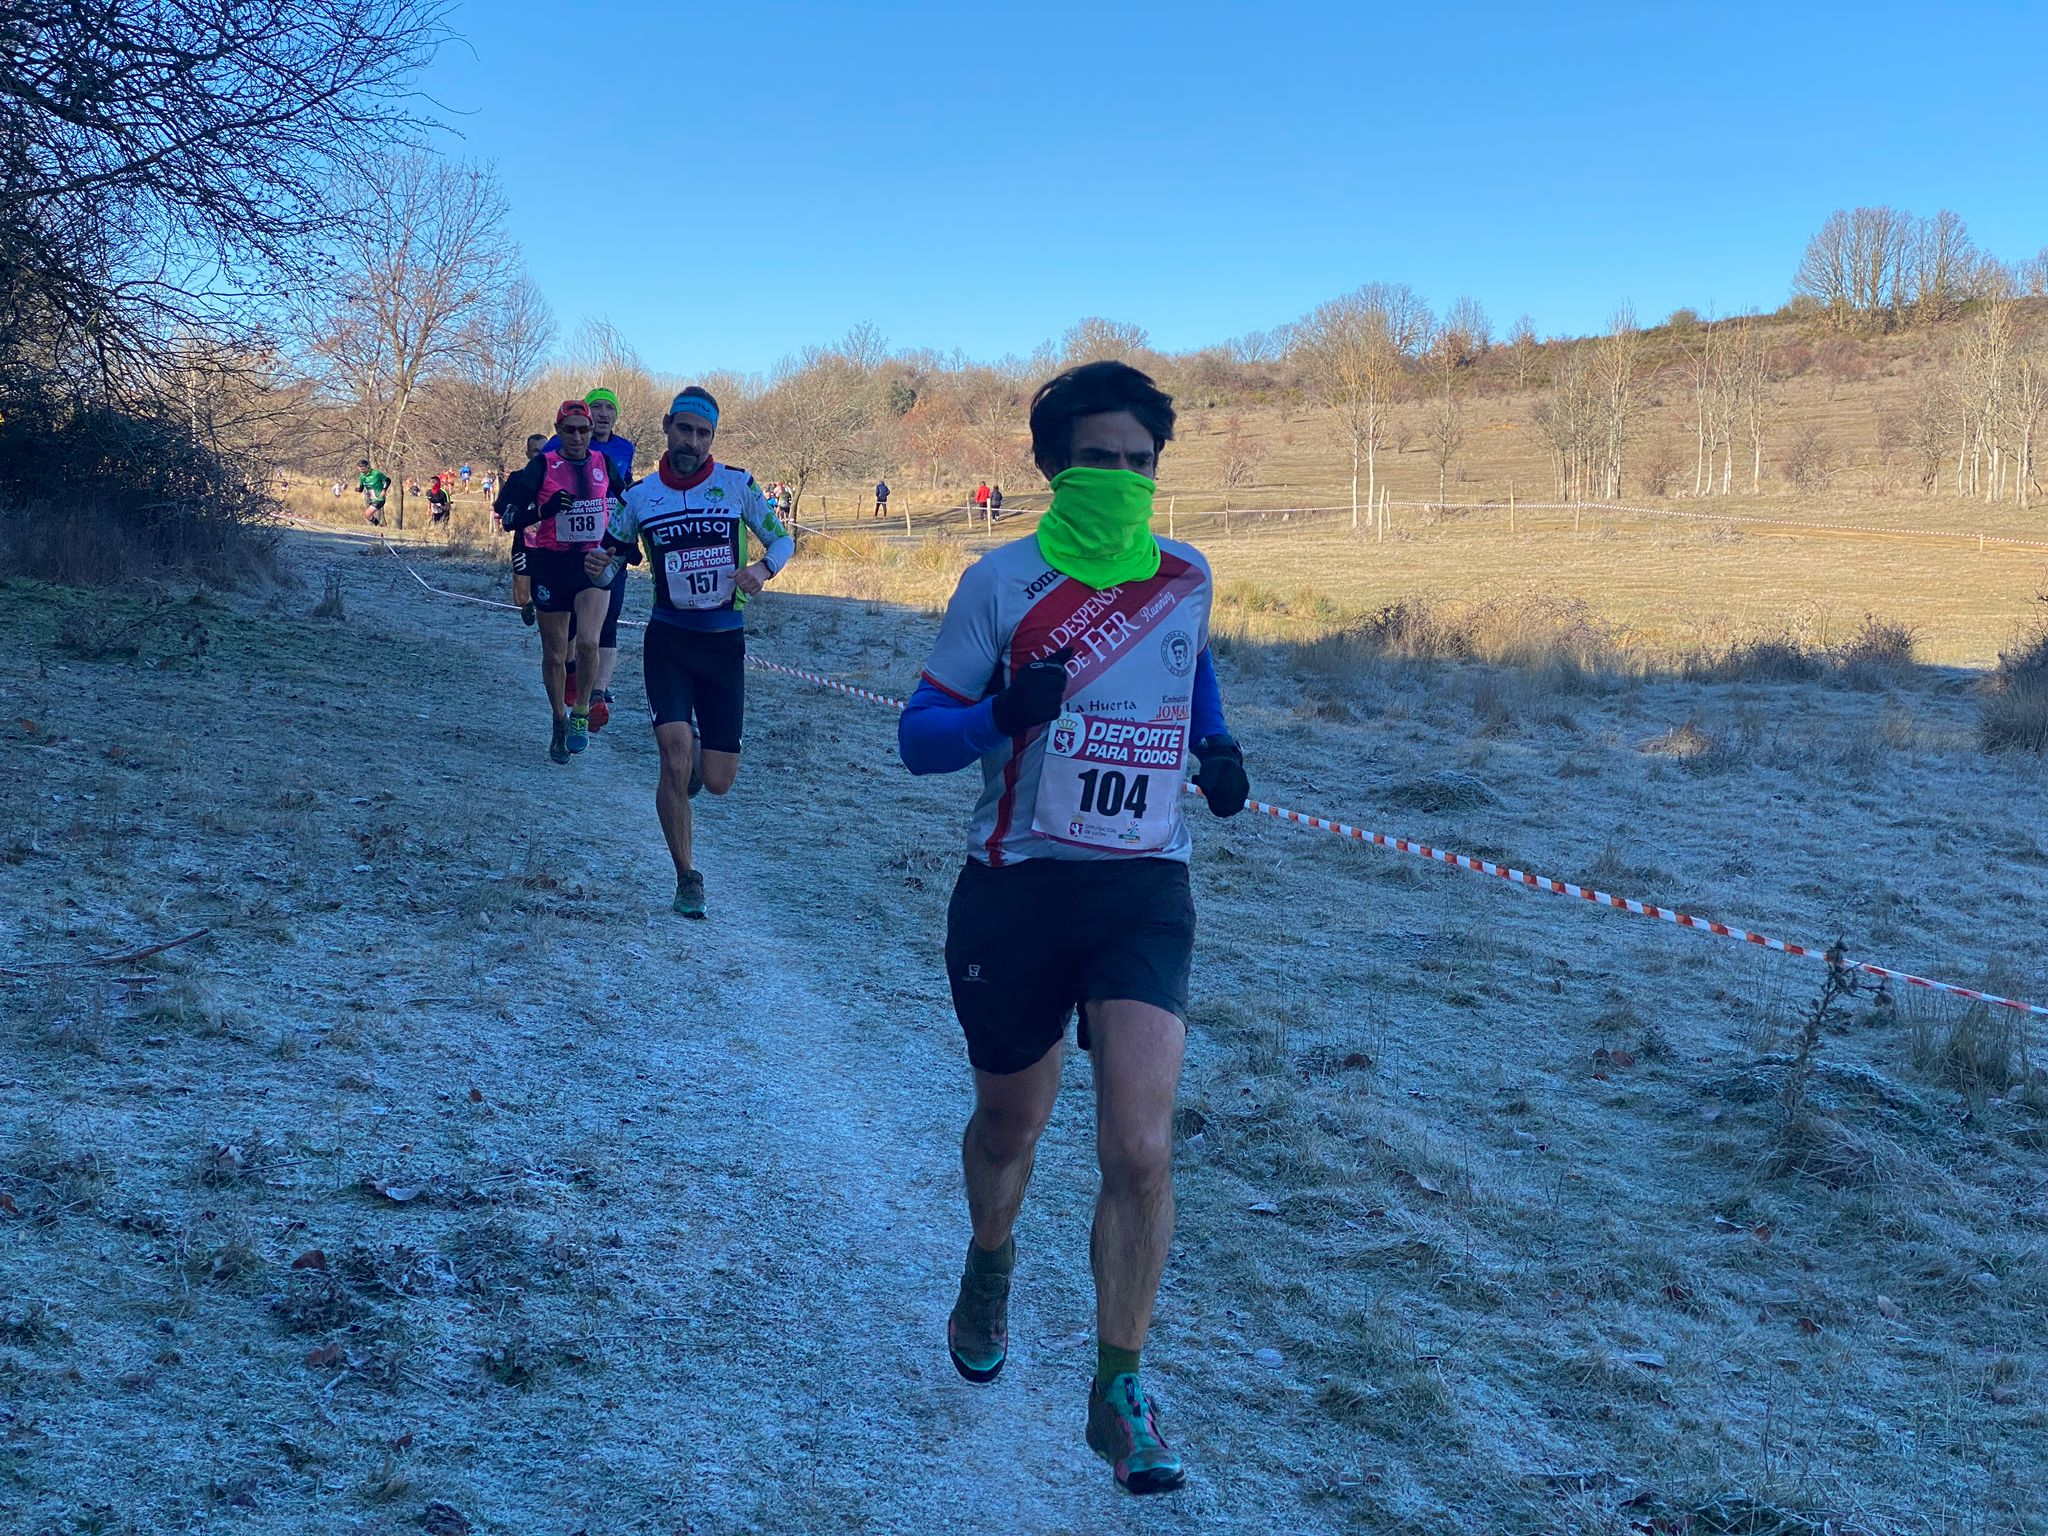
[586,385,797,918]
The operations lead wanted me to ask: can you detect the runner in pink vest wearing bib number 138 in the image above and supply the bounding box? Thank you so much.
[498,399,618,762]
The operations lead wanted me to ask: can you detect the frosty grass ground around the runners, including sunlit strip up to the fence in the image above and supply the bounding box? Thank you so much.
[0,520,2048,1536]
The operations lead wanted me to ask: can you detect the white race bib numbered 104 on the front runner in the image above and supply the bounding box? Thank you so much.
[1032,702,1188,854]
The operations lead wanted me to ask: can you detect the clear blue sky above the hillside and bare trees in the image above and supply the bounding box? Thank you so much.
[430,0,2048,373]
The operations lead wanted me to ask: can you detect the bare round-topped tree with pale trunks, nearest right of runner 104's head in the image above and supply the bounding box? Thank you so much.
[1294,283,1430,528]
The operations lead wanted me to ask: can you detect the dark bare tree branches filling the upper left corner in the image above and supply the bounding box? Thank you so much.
[0,0,446,385]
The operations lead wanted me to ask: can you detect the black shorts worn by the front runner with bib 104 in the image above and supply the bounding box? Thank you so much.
[946,858,1194,1073]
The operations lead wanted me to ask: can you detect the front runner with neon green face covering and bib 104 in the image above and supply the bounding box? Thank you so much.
[899,362,1249,1493]
